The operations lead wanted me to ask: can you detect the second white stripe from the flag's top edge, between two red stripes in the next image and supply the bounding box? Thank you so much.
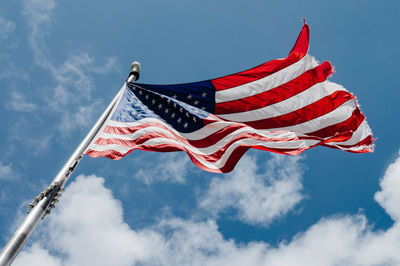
[218,81,346,122]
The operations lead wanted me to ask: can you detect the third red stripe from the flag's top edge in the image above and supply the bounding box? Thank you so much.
[244,91,354,129]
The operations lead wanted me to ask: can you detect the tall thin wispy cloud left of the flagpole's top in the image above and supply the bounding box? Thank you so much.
[20,0,115,136]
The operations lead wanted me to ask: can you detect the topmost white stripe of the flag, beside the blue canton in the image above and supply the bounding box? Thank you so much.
[215,54,318,103]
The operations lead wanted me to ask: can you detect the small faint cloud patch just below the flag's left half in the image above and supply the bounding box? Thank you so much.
[134,152,192,185]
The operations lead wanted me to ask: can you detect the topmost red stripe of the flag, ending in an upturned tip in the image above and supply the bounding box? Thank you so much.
[212,23,310,91]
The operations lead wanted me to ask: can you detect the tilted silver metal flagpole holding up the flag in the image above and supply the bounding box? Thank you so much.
[0,62,140,266]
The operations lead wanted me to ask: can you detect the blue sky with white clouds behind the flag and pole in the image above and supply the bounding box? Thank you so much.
[0,0,400,266]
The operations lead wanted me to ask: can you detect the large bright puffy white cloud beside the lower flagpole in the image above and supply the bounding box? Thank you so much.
[15,176,158,266]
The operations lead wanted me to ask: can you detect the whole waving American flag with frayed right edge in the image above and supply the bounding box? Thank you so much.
[86,23,373,173]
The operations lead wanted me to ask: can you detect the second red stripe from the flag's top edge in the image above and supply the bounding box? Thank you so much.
[215,62,333,115]
